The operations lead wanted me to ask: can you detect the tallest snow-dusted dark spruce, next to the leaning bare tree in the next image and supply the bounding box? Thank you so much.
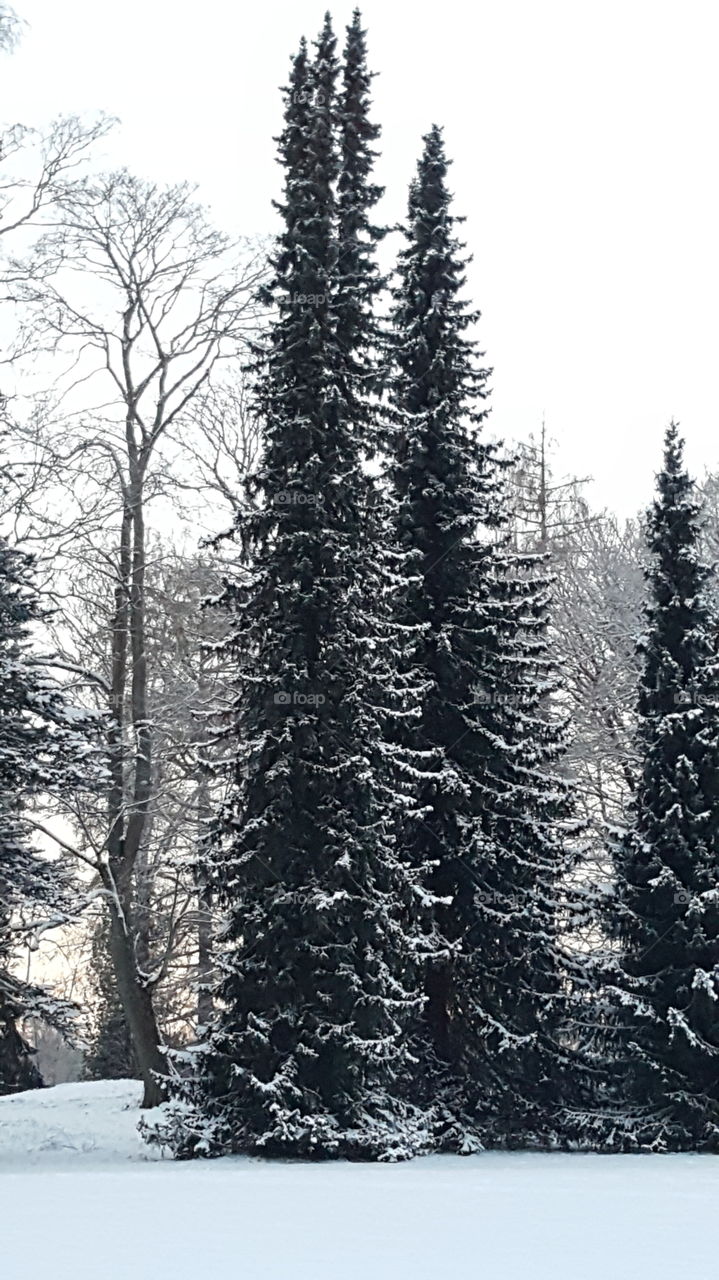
[151,18,425,1158]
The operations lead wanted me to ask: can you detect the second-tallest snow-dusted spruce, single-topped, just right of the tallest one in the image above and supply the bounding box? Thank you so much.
[390,127,583,1143]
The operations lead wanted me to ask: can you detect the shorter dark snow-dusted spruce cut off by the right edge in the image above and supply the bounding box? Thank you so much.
[609,424,719,1151]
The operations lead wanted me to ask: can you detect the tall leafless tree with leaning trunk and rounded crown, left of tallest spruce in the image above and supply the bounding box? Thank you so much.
[17,172,262,1106]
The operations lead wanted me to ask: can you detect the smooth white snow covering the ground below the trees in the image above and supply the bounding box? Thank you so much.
[0,1083,719,1280]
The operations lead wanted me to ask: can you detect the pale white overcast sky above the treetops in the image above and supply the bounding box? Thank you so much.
[0,0,719,512]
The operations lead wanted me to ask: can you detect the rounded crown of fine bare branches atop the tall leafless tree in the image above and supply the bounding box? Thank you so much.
[11,170,264,437]
